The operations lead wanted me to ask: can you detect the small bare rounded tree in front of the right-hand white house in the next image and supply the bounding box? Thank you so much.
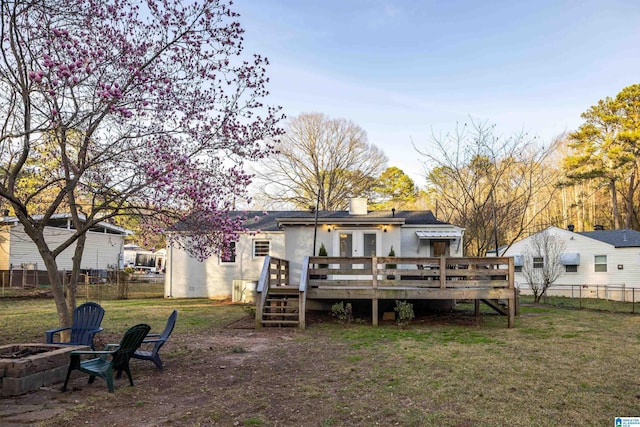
[522,229,565,303]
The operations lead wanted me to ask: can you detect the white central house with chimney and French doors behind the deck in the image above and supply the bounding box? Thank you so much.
[165,198,464,298]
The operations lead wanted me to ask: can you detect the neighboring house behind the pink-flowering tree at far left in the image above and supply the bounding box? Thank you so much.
[0,214,132,286]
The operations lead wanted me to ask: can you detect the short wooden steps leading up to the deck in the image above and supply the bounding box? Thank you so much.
[257,285,301,327]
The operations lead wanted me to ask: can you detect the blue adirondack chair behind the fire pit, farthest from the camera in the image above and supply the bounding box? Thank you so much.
[45,302,104,350]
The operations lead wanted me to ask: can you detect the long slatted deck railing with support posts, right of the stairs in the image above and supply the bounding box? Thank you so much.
[303,257,516,327]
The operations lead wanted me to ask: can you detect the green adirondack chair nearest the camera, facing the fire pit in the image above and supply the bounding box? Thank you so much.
[62,323,151,393]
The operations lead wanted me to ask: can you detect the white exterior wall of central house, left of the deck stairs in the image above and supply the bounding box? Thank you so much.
[165,232,284,299]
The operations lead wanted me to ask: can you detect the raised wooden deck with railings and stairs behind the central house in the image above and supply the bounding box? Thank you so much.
[256,257,516,328]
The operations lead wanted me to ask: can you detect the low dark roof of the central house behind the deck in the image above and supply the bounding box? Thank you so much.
[173,210,451,231]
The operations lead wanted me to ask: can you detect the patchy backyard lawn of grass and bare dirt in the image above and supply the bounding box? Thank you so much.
[0,299,640,427]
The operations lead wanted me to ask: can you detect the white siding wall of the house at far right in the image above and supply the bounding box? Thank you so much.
[505,227,640,287]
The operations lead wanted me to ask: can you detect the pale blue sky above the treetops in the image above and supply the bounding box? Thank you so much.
[233,0,640,187]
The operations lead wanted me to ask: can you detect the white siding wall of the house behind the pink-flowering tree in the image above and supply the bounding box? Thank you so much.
[9,225,124,270]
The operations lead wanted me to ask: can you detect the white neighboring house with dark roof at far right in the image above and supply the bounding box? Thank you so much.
[502,227,640,287]
